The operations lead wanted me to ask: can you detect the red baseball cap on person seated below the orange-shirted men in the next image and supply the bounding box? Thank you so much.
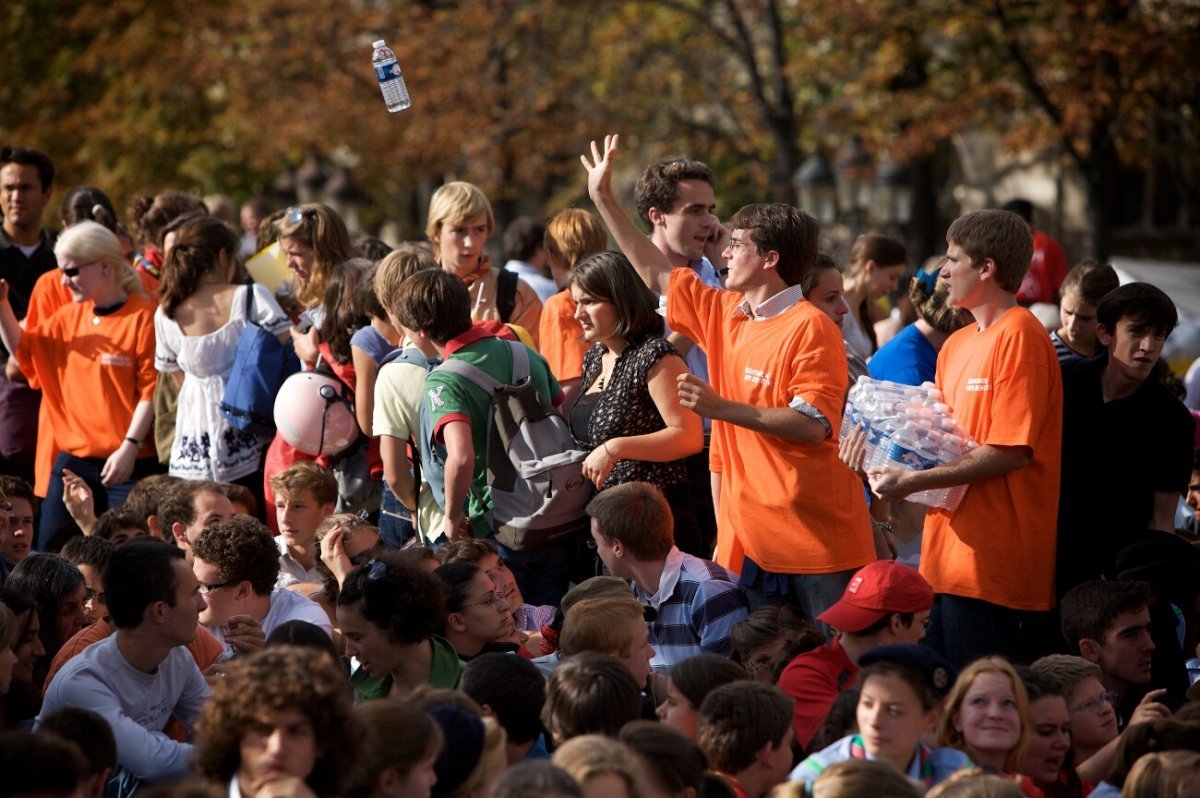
[817,559,934,634]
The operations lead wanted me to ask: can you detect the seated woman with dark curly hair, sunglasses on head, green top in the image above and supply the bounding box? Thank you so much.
[337,552,464,701]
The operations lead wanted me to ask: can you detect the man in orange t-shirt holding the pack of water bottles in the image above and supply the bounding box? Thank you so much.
[868,210,1062,667]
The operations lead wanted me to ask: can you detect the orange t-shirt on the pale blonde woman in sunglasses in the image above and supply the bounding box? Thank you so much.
[17,295,157,458]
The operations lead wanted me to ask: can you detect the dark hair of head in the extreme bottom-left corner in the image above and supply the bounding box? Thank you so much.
[0,731,88,798]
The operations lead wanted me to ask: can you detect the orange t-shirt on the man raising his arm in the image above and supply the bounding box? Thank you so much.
[667,269,875,574]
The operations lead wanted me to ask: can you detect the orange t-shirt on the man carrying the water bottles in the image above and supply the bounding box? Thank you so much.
[920,307,1062,610]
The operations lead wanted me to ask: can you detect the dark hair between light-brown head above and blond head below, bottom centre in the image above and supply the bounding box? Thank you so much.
[541,652,642,740]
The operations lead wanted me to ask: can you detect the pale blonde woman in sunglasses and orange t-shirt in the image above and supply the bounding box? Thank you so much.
[0,221,157,551]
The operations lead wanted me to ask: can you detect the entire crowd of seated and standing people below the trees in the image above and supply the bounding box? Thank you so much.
[0,136,1200,798]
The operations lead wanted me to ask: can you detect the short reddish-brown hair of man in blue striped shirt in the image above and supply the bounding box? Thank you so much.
[587,481,674,562]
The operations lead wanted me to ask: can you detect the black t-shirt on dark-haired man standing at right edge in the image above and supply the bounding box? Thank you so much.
[1057,354,1195,595]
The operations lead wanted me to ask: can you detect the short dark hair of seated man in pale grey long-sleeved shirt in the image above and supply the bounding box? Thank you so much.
[102,539,184,629]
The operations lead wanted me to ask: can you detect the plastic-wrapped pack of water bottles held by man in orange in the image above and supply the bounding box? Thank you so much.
[840,377,979,510]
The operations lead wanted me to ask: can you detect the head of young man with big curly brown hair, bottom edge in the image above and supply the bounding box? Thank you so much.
[193,646,364,798]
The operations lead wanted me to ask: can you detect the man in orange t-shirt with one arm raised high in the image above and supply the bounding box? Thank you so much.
[584,137,875,618]
